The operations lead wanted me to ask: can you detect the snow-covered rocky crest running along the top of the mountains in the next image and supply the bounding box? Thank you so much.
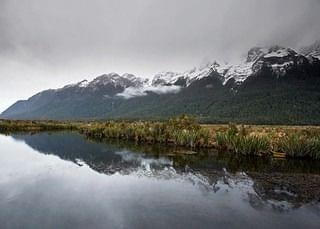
[50,41,320,99]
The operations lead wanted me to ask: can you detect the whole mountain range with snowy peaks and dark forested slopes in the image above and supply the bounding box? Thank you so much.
[0,41,320,124]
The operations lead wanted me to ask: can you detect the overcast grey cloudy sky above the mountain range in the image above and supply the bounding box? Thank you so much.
[0,0,320,112]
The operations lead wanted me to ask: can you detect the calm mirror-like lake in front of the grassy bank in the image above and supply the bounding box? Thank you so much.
[0,132,320,229]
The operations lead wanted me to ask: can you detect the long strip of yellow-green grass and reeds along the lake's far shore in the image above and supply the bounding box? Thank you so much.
[0,115,320,160]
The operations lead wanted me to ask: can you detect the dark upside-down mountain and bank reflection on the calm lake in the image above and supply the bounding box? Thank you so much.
[8,133,320,206]
